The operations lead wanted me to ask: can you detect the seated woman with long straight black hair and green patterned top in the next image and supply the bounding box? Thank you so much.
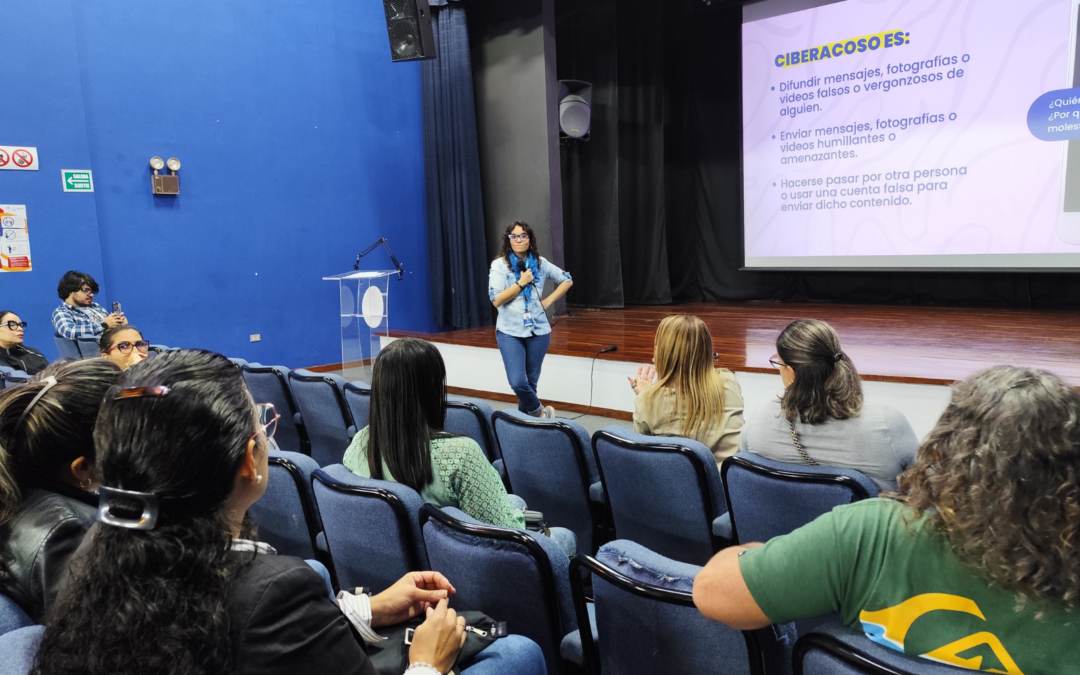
[343,338,525,529]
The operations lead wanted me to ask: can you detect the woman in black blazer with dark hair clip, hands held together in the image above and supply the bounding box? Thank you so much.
[33,350,544,675]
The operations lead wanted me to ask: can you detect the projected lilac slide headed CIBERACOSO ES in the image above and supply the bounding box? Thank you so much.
[742,0,1080,269]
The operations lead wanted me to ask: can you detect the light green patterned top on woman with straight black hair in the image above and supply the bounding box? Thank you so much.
[345,427,525,529]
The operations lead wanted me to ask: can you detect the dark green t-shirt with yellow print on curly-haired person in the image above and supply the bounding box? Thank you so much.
[739,499,1080,675]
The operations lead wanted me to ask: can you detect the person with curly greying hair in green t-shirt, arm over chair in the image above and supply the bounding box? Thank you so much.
[693,366,1080,675]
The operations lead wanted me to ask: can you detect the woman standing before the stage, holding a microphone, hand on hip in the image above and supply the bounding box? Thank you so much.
[487,221,573,417]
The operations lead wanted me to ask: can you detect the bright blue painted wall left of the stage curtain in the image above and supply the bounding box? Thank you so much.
[0,0,434,367]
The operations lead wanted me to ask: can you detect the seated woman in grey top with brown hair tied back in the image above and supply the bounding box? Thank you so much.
[740,319,919,490]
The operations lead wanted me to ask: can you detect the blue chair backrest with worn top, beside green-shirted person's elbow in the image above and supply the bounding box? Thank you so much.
[570,539,764,675]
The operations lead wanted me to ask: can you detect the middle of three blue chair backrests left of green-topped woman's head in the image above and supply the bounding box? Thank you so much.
[288,369,356,467]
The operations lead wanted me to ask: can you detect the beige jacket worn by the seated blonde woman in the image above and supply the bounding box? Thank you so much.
[634,368,743,463]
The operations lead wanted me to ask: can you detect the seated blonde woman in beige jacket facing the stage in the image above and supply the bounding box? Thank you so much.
[630,314,743,463]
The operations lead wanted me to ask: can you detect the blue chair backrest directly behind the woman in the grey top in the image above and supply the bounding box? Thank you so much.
[720,453,878,542]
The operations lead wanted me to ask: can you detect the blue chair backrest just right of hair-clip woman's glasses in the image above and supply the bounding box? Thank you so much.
[247,450,323,559]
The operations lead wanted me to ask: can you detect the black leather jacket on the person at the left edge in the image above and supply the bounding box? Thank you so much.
[0,486,97,623]
